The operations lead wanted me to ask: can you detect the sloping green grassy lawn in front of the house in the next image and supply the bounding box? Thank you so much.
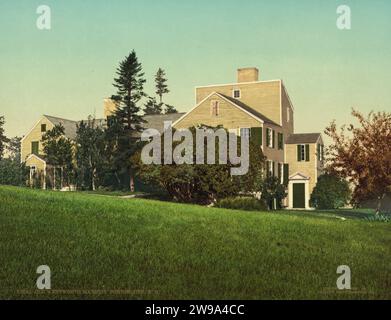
[0,187,391,299]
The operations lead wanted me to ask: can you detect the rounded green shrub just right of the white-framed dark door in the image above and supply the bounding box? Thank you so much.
[310,174,350,209]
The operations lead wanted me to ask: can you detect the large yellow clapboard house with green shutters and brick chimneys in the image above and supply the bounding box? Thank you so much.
[21,68,323,209]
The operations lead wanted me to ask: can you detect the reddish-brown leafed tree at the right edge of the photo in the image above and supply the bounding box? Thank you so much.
[325,109,391,212]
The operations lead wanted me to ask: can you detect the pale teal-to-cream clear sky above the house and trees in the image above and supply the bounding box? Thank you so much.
[0,0,391,137]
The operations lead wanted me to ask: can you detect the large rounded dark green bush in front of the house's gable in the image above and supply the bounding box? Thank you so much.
[132,125,265,204]
